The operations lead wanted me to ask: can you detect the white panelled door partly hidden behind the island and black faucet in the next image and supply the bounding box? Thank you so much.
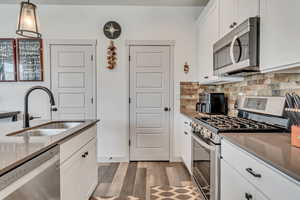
[50,45,95,120]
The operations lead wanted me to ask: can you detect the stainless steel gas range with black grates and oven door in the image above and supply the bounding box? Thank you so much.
[191,96,288,200]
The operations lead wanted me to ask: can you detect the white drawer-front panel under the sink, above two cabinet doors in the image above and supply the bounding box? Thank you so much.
[60,126,97,163]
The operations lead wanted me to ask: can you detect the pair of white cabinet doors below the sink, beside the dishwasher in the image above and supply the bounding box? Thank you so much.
[60,126,98,200]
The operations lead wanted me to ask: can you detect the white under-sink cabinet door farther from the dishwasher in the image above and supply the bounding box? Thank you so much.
[81,139,98,199]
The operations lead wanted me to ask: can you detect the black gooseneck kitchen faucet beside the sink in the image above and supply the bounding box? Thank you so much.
[23,86,55,128]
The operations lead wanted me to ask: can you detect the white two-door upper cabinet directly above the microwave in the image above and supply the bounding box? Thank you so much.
[220,0,259,37]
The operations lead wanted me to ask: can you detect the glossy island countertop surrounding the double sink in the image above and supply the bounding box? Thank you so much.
[0,120,99,176]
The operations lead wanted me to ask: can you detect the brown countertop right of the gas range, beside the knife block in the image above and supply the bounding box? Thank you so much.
[221,133,300,182]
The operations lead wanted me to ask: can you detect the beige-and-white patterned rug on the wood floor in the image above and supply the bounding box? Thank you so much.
[150,186,201,200]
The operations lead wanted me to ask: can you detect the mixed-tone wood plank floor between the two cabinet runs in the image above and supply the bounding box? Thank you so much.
[94,162,192,200]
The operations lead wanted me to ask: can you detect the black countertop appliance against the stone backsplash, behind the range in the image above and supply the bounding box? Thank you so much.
[196,93,227,115]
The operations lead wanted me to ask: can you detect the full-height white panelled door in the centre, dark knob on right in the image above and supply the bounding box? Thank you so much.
[130,46,170,160]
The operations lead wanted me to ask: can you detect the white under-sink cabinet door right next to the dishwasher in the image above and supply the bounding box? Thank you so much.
[60,148,84,200]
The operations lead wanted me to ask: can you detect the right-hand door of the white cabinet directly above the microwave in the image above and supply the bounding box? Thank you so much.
[237,0,259,24]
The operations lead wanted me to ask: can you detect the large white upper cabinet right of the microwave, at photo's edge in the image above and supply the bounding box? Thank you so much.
[260,0,300,72]
